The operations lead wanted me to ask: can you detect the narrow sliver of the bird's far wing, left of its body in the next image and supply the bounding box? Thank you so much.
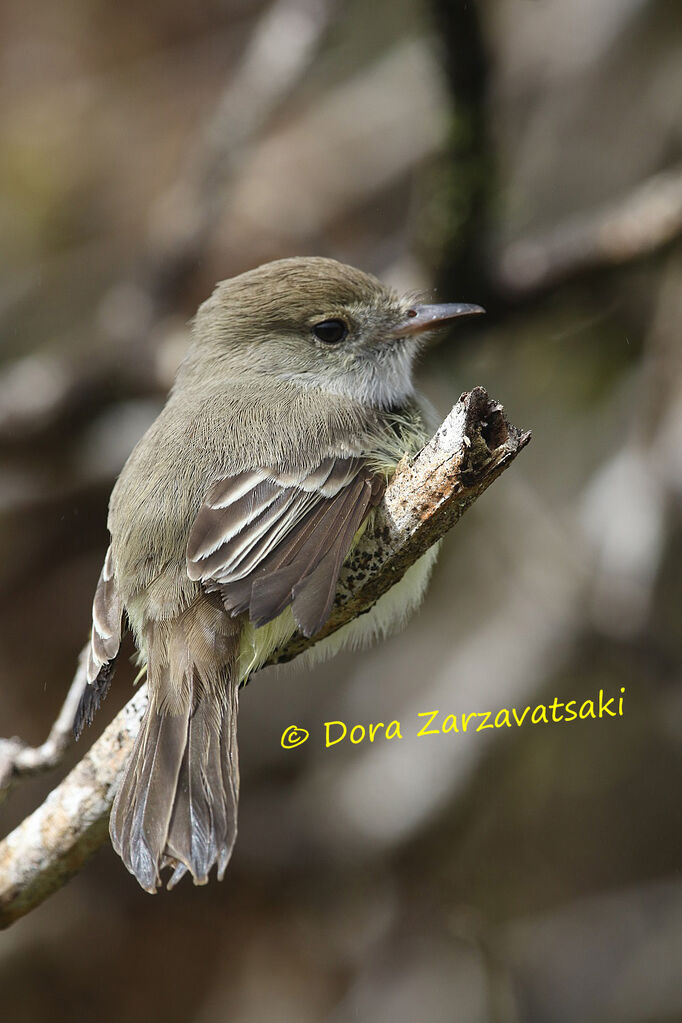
[74,547,123,739]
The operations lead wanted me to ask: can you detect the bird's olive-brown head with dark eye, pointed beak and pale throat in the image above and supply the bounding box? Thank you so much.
[182,257,484,407]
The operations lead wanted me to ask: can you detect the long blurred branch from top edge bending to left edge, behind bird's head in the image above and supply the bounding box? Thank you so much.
[0,0,342,443]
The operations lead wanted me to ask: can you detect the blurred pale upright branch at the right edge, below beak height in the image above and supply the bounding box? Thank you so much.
[579,257,682,640]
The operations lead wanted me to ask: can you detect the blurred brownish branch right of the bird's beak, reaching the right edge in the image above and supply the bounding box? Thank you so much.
[498,168,682,299]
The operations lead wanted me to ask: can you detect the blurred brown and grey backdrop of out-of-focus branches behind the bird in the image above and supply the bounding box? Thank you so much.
[0,0,682,1023]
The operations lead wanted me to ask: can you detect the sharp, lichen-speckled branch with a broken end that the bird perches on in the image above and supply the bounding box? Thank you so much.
[0,388,530,927]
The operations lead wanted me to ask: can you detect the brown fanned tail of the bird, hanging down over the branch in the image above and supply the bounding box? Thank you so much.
[109,597,239,892]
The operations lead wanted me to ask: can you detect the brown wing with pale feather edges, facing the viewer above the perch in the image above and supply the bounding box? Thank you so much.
[187,457,385,636]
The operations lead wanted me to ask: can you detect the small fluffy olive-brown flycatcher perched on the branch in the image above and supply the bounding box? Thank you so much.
[76,258,483,892]
